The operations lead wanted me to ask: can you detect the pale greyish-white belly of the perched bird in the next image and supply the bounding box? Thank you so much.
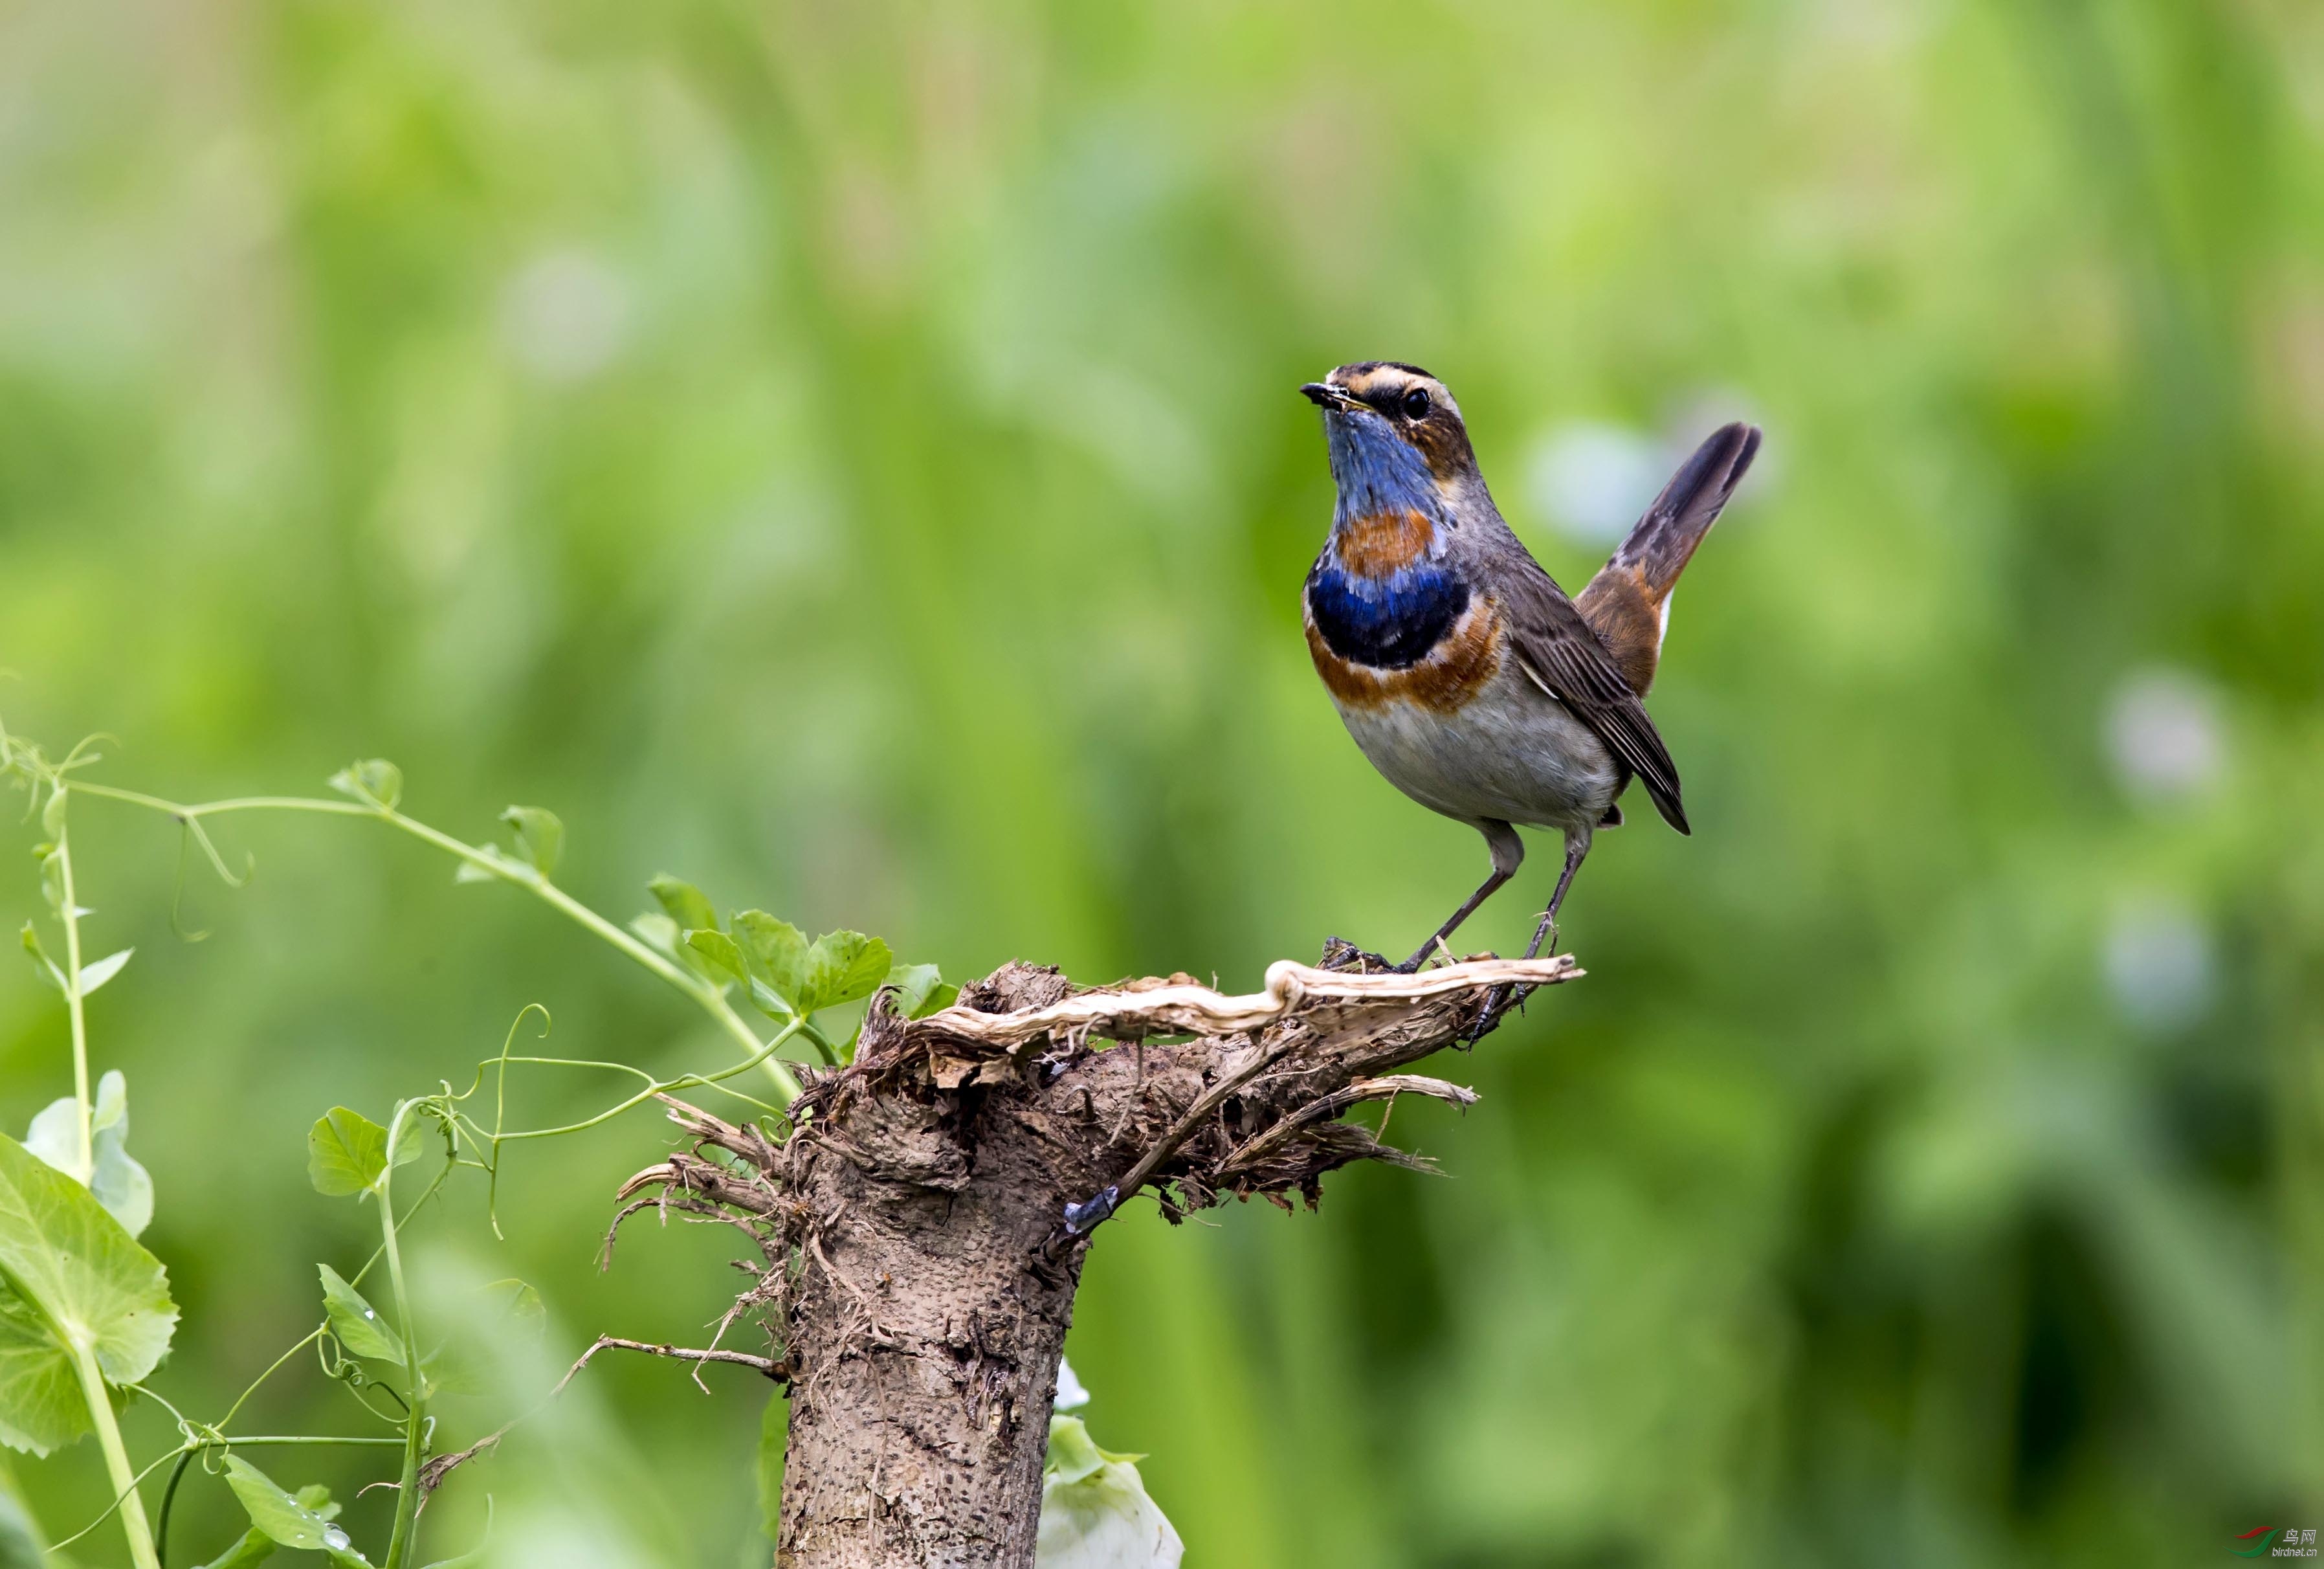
[1336,662,1622,830]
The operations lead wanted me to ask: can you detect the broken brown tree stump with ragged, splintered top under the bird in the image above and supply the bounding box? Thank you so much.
[609,958,1580,1569]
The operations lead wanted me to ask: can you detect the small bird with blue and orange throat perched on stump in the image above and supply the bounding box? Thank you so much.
[1299,361,1759,972]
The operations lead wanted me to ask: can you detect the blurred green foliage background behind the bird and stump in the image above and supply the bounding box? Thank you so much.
[0,0,2324,1569]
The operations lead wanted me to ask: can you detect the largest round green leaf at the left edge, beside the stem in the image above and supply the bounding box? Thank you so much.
[0,1134,177,1452]
